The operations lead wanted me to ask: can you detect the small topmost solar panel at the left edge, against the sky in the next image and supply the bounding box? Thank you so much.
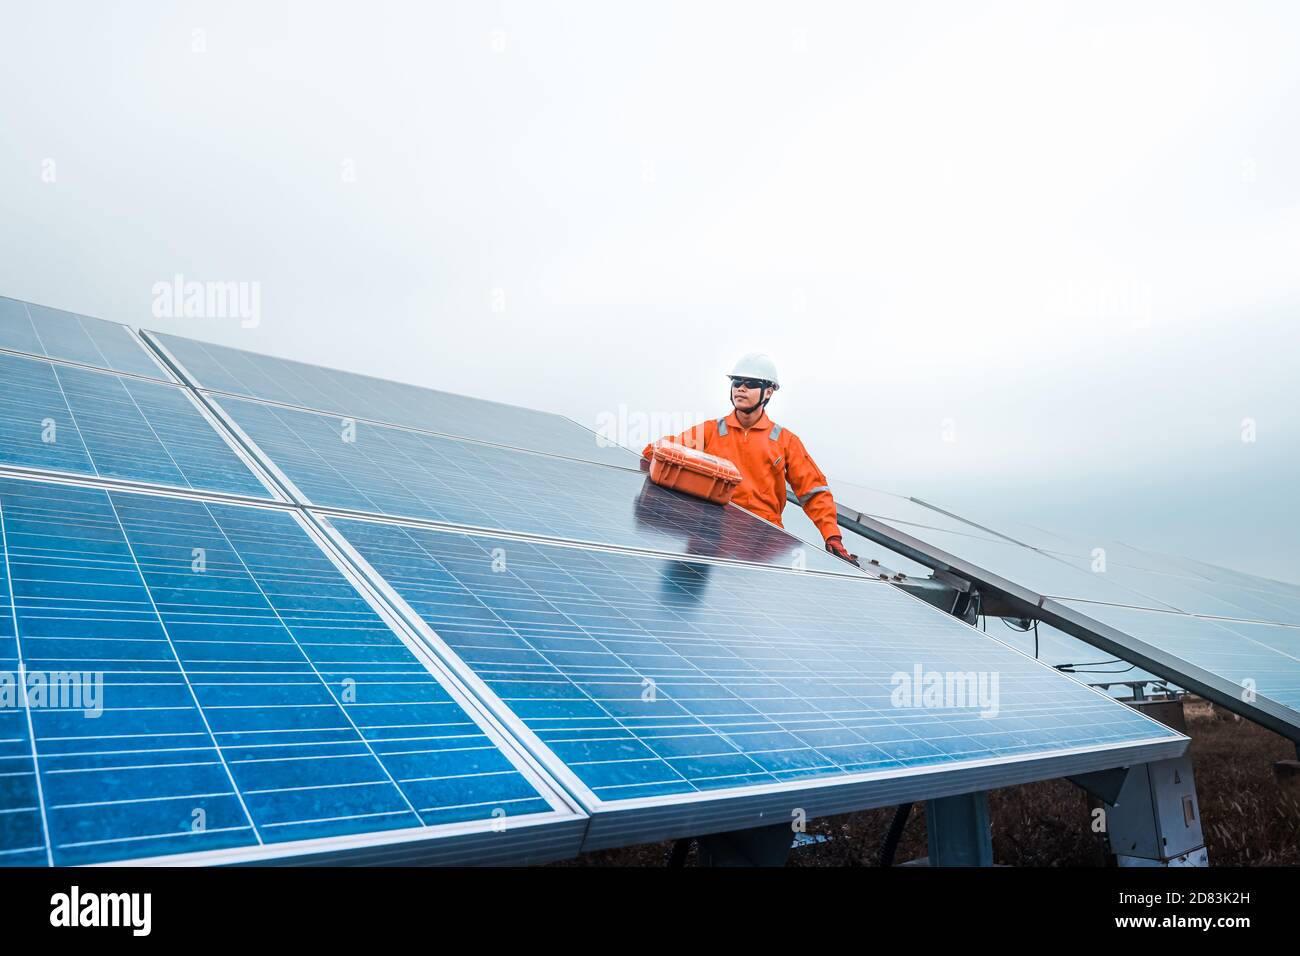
[0,297,172,381]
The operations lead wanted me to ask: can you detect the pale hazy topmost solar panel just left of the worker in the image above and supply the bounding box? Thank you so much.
[148,332,637,468]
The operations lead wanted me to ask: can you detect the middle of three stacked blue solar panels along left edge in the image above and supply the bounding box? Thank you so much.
[0,352,270,498]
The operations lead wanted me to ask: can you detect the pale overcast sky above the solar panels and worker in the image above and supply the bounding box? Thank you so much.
[0,1,1300,580]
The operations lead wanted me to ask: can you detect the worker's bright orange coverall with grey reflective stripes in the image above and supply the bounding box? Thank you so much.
[641,410,840,538]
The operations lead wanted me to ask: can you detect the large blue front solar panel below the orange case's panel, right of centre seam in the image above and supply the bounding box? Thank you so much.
[322,518,1186,849]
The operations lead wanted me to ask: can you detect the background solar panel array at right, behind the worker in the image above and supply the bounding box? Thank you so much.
[826,488,1300,740]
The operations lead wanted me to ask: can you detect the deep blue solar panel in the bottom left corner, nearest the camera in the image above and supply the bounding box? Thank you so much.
[0,479,574,865]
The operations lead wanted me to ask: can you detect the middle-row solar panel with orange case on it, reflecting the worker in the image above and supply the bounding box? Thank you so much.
[208,398,857,574]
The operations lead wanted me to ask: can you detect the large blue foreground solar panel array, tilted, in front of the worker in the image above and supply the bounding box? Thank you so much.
[0,300,1186,864]
